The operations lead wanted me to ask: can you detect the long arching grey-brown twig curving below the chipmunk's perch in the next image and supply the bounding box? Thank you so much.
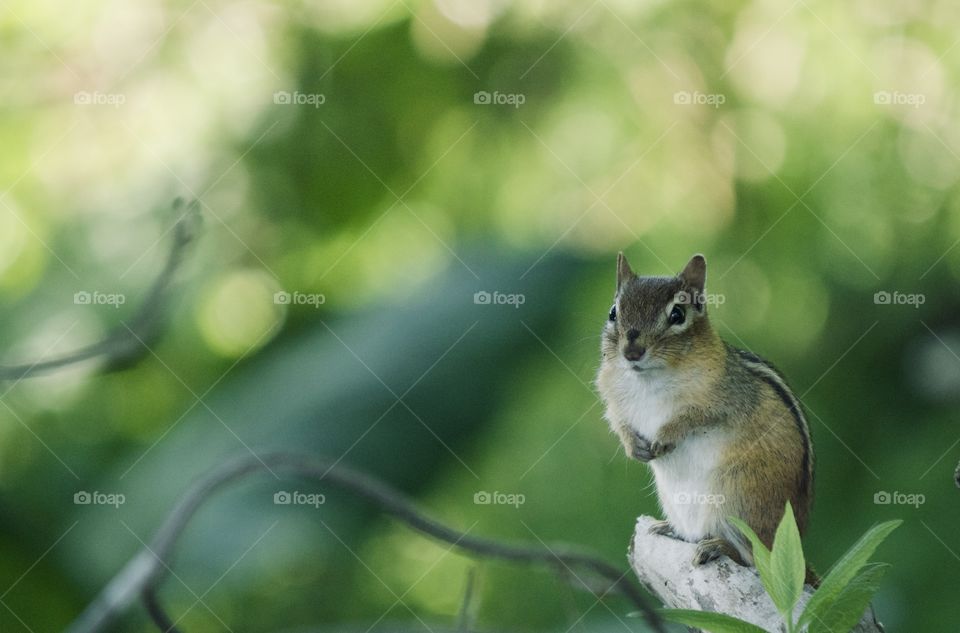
[67,453,665,633]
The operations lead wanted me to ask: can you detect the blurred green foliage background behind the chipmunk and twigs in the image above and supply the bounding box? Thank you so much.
[0,0,960,633]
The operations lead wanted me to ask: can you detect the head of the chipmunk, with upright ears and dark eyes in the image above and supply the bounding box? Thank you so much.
[602,253,710,372]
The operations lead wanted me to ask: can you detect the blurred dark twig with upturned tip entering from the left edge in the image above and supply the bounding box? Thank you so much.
[0,199,199,381]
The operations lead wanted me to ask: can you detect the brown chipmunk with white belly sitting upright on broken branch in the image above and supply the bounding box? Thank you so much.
[596,253,816,572]
